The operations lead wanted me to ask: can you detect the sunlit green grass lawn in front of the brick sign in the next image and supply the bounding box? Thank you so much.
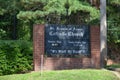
[0,69,120,80]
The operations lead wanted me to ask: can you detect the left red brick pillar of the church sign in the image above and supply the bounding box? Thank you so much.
[33,25,44,71]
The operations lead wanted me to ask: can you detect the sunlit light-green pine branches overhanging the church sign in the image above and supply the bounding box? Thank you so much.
[17,0,99,23]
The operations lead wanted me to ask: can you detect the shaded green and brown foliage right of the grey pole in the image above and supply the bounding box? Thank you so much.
[107,0,120,64]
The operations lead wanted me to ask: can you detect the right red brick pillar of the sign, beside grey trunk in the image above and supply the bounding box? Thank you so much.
[91,26,100,68]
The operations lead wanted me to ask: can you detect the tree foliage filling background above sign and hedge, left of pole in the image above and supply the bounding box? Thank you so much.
[0,0,99,40]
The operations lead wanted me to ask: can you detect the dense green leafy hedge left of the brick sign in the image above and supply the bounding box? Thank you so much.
[0,40,33,75]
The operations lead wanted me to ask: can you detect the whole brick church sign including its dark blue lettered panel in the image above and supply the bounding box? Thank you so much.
[33,24,100,71]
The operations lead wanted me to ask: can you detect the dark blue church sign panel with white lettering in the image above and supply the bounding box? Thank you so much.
[45,24,90,57]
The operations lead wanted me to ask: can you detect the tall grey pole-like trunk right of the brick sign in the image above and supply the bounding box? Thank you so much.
[100,0,107,67]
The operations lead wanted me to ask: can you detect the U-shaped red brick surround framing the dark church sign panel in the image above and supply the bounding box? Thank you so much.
[33,25,100,71]
